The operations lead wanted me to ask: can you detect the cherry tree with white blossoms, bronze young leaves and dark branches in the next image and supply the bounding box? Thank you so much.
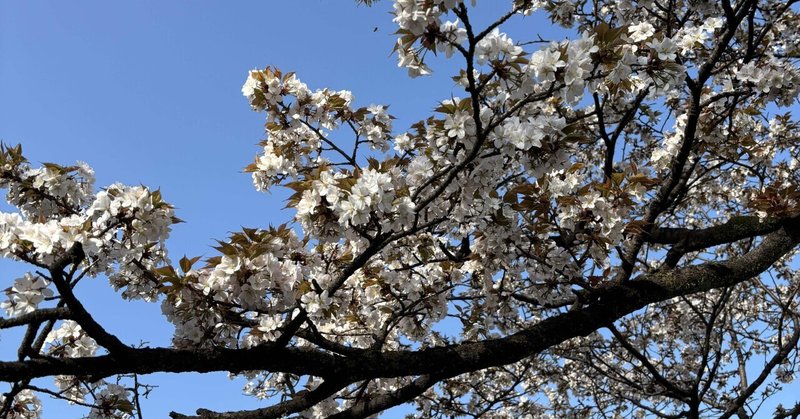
[0,0,800,418]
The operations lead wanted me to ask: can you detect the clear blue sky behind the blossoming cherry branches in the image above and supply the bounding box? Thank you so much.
[0,0,796,419]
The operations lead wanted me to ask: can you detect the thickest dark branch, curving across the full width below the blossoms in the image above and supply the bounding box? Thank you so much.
[0,225,800,392]
